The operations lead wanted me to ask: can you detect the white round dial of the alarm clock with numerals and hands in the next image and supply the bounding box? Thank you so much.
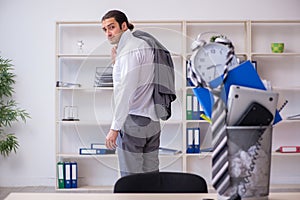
[191,43,238,83]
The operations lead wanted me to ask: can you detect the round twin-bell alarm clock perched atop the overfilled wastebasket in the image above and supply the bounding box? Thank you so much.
[189,37,238,86]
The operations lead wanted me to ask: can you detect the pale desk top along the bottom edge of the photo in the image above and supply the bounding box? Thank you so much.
[5,192,300,200]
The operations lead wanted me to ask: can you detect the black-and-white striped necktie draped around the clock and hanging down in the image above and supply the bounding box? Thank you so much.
[188,35,235,195]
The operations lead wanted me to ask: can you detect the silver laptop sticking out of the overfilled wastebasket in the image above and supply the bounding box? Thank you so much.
[226,85,279,126]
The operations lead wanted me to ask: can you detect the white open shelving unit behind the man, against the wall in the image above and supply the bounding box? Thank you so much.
[55,21,300,191]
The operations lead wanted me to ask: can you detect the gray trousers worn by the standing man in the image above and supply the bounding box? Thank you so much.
[117,115,161,176]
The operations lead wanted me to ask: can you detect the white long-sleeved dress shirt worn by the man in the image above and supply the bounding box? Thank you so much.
[111,30,159,130]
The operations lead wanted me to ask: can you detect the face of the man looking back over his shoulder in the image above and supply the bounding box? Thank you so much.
[102,17,126,44]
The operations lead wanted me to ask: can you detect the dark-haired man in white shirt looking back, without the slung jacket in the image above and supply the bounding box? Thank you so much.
[102,10,160,176]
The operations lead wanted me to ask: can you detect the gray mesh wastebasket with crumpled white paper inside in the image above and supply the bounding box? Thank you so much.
[219,125,272,200]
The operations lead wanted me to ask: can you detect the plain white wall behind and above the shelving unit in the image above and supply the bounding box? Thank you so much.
[0,0,300,186]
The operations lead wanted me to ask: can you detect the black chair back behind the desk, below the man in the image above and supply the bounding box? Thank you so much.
[114,172,208,193]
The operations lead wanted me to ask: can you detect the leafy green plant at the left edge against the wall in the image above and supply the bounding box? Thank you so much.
[0,56,30,157]
